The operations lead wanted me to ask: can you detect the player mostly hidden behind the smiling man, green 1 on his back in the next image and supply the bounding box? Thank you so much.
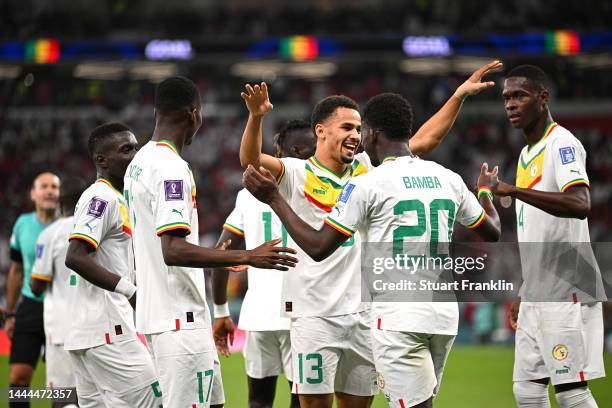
[213,120,315,407]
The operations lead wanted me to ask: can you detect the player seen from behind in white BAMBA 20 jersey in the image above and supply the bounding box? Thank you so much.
[245,94,500,408]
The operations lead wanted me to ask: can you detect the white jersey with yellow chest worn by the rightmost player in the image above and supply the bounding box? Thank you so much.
[516,122,605,301]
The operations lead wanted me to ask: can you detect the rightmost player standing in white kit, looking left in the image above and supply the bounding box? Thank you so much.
[492,65,605,408]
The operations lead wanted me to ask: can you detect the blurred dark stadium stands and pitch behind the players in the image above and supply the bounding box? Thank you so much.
[0,0,612,407]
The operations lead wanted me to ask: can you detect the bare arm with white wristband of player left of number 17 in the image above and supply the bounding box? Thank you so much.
[65,239,136,307]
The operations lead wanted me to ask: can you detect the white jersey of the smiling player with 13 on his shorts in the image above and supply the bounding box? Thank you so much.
[278,153,371,317]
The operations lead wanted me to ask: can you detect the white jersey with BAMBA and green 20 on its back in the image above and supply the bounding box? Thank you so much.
[326,156,485,335]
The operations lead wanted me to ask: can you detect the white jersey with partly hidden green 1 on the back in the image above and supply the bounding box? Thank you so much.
[223,189,292,331]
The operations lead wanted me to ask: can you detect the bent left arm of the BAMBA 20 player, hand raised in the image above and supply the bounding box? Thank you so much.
[242,166,348,262]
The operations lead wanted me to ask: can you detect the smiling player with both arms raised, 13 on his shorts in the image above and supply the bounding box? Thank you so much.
[240,61,501,407]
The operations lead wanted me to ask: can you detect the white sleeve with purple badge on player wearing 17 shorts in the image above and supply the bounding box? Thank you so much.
[153,165,195,236]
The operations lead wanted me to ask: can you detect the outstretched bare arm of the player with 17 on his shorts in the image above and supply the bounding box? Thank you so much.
[161,230,297,271]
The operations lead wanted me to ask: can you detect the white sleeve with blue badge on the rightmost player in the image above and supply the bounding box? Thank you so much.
[551,134,589,192]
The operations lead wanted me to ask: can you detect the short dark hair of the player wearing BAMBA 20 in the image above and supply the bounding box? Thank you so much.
[363,93,413,140]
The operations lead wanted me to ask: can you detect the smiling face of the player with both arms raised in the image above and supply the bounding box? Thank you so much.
[315,107,361,164]
